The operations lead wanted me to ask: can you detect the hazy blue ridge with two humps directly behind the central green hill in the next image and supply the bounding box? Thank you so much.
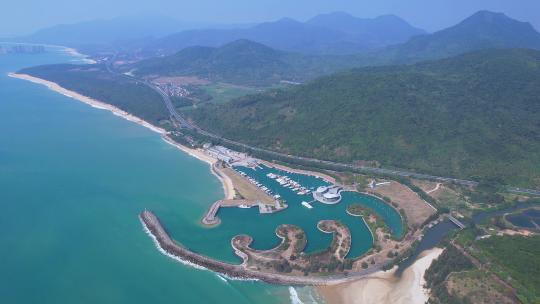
[143,12,425,54]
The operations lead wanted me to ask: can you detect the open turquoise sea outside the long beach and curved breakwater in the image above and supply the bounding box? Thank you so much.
[0,49,315,304]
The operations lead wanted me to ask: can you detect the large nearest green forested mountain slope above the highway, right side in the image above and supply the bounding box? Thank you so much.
[186,49,540,187]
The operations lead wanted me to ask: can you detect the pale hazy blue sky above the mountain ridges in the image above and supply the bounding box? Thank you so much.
[0,0,540,36]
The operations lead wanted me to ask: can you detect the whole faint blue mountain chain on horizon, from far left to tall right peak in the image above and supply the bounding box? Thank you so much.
[9,12,425,57]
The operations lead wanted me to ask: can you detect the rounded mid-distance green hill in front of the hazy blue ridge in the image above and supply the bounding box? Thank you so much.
[128,40,361,86]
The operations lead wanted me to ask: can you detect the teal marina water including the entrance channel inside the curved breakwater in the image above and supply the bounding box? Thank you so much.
[162,166,403,262]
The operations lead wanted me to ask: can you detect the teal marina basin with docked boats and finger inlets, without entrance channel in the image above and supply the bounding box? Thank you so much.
[219,166,402,258]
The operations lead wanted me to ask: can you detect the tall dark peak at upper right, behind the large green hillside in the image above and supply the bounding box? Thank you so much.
[375,11,540,63]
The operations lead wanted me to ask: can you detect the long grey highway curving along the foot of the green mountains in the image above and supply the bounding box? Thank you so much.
[105,55,540,196]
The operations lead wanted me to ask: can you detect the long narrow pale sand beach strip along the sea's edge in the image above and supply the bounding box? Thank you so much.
[8,71,234,199]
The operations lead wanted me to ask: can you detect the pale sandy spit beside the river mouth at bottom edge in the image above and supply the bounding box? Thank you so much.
[318,248,442,304]
